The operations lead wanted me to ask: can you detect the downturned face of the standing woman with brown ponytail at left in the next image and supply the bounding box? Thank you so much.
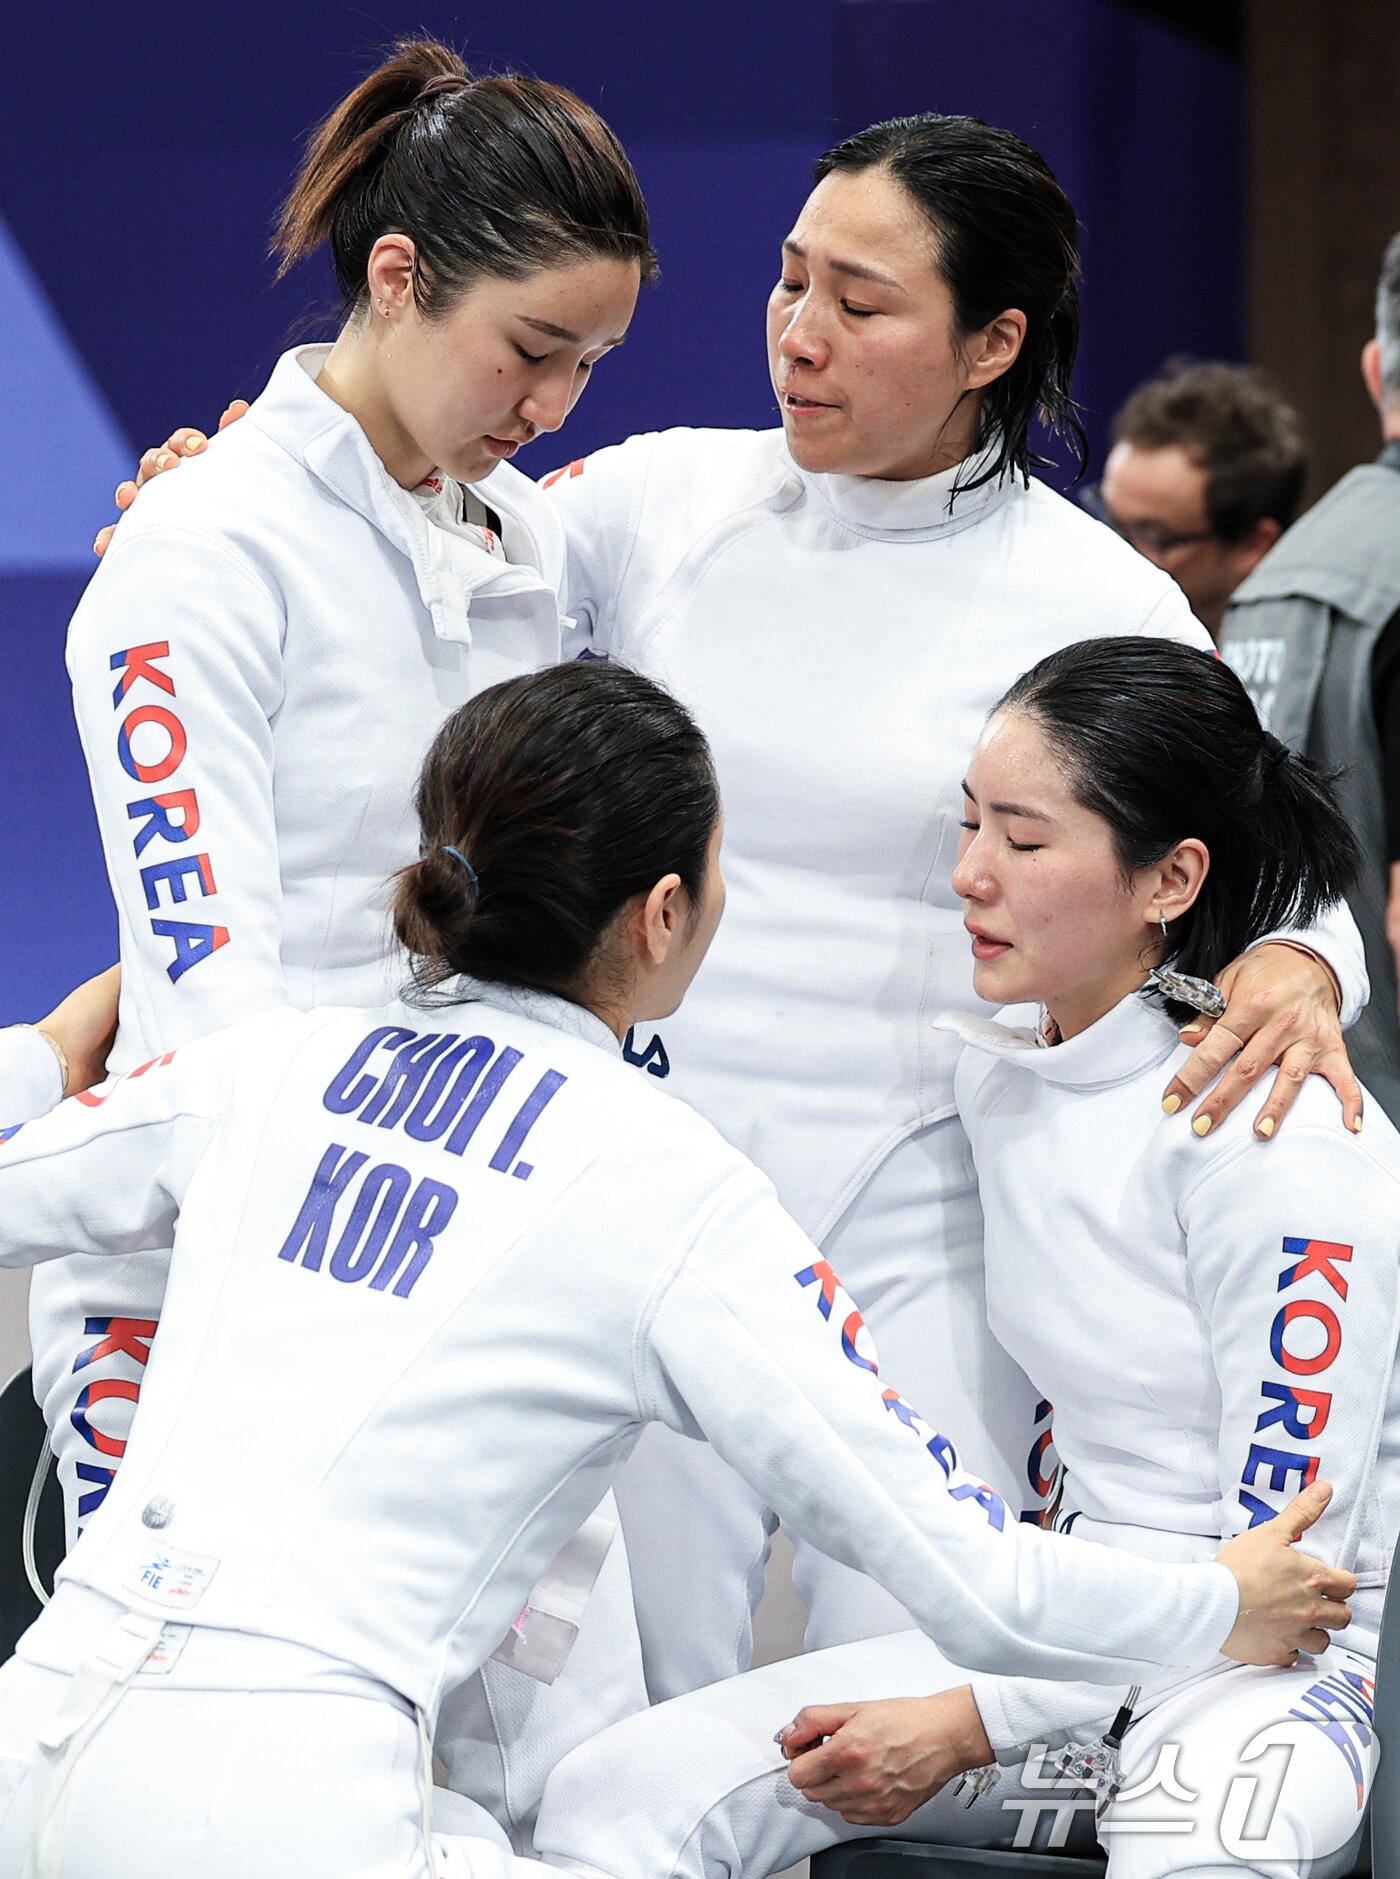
[379,257,641,483]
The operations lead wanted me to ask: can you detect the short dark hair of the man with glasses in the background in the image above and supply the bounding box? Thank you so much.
[1112,359,1308,541]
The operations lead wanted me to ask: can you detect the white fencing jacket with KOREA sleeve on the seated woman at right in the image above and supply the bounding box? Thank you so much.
[945,994,1400,1747]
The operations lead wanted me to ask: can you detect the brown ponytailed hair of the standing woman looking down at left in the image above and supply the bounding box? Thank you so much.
[272,39,656,314]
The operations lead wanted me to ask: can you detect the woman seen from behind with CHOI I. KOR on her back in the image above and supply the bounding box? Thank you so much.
[0,665,1355,1879]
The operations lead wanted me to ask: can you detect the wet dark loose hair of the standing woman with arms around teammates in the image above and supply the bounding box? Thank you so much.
[816,111,1088,489]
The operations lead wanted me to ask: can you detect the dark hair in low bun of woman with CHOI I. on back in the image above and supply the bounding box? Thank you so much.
[395,661,720,996]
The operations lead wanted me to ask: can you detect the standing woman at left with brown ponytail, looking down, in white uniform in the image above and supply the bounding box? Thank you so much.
[30,45,650,1834]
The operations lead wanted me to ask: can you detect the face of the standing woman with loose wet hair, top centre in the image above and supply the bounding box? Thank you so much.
[769,169,977,481]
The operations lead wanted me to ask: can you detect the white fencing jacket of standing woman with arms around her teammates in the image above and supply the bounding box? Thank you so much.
[545,430,1366,1238]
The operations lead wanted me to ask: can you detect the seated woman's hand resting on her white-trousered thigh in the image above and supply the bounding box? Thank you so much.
[780,1684,996,1826]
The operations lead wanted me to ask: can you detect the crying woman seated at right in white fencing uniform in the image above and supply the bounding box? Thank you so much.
[536,639,1400,1879]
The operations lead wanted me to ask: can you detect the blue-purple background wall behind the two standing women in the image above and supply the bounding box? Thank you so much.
[0,0,1244,1022]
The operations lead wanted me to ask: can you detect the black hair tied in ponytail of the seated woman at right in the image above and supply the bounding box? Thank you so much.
[996,637,1361,979]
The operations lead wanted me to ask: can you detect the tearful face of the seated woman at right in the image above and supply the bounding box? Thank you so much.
[953,710,1156,1037]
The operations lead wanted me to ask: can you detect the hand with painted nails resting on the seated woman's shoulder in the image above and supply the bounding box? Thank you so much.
[1161,941,1362,1141]
